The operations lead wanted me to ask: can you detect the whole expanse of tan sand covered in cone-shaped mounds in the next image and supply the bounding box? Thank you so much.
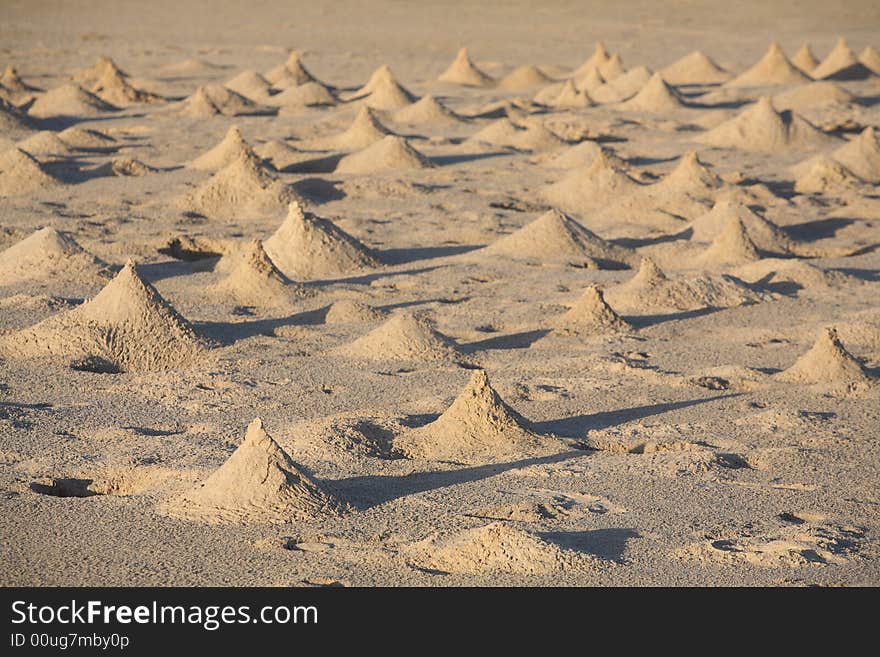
[0,0,880,586]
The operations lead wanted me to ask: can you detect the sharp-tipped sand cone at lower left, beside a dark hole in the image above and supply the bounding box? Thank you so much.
[162,418,346,524]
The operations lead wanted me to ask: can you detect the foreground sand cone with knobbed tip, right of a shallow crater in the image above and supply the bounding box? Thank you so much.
[394,370,559,463]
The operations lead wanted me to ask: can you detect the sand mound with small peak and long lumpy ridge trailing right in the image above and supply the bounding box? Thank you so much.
[605,258,764,313]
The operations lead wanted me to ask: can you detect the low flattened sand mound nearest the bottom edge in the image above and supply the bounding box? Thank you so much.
[408,522,580,575]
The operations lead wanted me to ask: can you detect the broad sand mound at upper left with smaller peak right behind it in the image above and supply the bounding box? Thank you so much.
[185,151,299,218]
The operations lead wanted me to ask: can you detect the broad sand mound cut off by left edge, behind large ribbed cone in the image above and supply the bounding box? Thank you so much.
[0,227,107,285]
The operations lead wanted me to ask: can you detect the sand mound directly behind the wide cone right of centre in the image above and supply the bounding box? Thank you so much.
[542,149,640,213]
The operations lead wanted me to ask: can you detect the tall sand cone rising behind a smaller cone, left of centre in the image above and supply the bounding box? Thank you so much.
[263,203,380,280]
